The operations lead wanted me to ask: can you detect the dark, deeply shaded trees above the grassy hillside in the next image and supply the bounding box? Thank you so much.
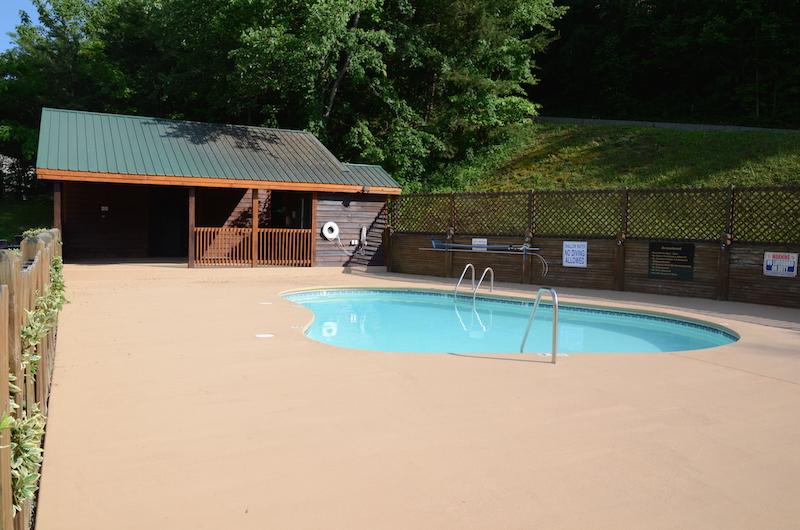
[531,0,800,128]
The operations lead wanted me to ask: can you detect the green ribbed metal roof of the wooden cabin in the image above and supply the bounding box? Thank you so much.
[36,108,400,188]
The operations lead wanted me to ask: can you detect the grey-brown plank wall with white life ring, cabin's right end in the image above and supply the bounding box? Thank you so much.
[313,193,386,266]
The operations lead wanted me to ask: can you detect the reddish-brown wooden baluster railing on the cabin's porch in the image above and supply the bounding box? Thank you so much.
[194,227,314,267]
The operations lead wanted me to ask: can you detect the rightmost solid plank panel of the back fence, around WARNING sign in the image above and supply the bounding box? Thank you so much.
[728,244,800,307]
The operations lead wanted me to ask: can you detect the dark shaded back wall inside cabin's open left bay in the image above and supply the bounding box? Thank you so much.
[61,182,148,259]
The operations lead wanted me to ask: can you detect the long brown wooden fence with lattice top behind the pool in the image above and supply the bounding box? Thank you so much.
[386,187,800,307]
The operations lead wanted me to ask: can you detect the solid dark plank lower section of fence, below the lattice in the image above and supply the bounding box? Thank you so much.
[390,232,800,308]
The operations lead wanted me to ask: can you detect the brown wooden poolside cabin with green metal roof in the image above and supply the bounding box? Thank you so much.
[36,108,400,267]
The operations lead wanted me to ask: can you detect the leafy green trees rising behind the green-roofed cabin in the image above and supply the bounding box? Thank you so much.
[0,0,564,188]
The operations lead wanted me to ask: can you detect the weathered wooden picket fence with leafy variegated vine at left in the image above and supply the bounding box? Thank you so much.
[0,229,61,530]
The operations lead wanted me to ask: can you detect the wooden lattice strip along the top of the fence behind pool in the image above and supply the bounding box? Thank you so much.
[389,187,800,243]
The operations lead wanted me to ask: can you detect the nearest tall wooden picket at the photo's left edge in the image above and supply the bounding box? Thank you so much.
[0,285,14,530]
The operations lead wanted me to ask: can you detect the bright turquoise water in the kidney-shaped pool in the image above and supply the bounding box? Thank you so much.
[285,289,737,353]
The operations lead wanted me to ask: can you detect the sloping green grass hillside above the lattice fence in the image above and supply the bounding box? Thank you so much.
[431,124,800,190]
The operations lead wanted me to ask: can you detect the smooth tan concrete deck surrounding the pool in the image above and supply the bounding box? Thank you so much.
[37,263,800,530]
